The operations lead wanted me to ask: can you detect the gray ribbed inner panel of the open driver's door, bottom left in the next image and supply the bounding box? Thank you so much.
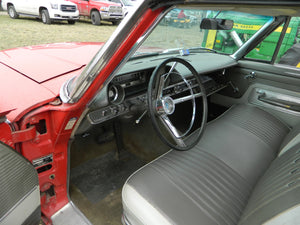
[0,142,41,225]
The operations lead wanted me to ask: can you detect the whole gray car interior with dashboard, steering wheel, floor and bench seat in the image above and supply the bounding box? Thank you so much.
[69,5,300,225]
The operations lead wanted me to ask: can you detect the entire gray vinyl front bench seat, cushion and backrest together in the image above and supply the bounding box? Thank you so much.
[122,105,300,225]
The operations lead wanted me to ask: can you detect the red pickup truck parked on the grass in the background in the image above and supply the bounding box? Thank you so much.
[68,0,124,25]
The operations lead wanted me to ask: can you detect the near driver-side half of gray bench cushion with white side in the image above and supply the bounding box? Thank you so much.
[122,148,251,225]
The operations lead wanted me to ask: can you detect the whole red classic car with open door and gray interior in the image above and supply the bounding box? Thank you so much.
[0,0,300,225]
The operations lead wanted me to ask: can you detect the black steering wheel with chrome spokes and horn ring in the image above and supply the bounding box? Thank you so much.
[147,57,208,151]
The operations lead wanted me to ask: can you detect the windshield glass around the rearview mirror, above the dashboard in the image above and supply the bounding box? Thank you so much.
[133,9,272,57]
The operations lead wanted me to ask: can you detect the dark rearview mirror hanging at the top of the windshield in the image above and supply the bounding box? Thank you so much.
[200,18,233,30]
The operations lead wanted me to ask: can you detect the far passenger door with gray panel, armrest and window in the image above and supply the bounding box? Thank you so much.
[209,17,300,127]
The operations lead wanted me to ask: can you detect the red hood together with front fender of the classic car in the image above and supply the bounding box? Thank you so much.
[0,43,103,121]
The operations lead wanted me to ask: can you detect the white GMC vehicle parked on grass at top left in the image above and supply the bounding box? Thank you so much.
[2,0,79,24]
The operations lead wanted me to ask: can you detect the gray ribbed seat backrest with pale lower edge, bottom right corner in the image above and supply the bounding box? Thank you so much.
[239,143,300,225]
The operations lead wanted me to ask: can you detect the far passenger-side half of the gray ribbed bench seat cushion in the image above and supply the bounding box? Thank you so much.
[198,105,289,186]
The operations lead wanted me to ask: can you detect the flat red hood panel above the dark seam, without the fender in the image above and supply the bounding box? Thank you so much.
[0,43,101,84]
